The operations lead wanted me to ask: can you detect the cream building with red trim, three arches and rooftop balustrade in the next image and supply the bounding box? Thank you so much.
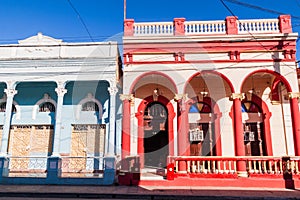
[120,15,300,186]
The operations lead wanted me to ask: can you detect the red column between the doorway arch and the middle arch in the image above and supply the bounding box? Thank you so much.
[177,98,190,171]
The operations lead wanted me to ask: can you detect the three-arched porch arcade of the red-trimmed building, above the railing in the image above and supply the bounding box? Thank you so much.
[122,71,300,168]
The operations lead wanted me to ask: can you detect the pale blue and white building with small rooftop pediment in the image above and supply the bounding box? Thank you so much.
[0,33,122,176]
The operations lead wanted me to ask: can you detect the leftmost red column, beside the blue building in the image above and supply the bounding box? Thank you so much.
[122,97,130,159]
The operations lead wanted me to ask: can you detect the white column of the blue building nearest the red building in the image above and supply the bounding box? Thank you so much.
[108,86,118,155]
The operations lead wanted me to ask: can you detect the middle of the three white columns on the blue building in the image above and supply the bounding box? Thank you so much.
[52,87,67,156]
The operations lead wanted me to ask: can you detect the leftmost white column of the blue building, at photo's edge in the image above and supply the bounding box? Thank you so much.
[1,89,18,155]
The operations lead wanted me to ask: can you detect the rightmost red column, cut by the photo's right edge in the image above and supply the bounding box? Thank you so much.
[289,93,300,156]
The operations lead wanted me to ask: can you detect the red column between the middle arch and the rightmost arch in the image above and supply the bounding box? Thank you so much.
[232,93,247,176]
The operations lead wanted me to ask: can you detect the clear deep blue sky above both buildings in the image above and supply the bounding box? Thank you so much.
[0,0,300,60]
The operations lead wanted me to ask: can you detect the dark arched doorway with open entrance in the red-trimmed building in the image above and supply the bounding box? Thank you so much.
[143,101,169,167]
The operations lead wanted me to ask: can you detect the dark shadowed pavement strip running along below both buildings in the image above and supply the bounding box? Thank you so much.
[0,185,300,199]
